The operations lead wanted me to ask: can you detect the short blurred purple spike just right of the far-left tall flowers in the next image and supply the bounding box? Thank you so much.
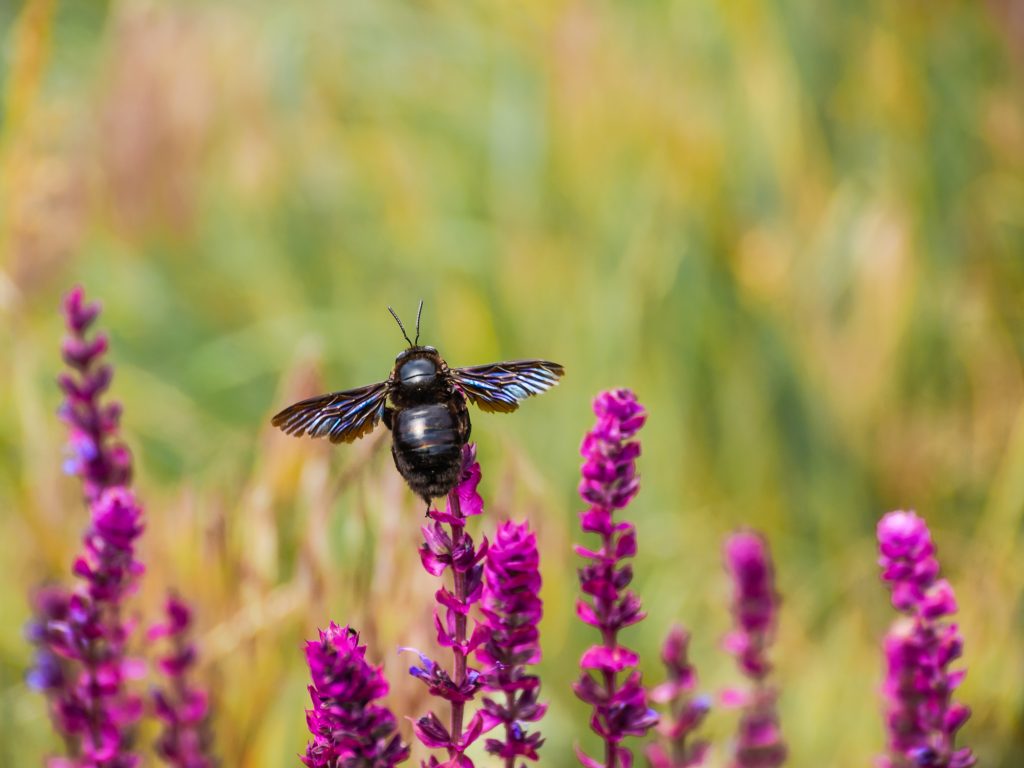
[146,595,214,768]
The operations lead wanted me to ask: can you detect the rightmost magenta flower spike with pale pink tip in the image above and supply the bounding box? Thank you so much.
[878,511,975,768]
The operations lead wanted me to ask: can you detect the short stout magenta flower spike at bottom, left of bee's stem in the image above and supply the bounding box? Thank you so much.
[299,622,409,768]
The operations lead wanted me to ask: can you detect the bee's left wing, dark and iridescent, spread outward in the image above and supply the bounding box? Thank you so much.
[270,379,391,442]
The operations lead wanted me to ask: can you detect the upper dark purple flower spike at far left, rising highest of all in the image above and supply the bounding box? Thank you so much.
[57,287,131,501]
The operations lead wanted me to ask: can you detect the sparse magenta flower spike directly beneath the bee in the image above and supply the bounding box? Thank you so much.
[410,445,487,768]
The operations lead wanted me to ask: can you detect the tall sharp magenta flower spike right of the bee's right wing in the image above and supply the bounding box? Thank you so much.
[573,389,657,768]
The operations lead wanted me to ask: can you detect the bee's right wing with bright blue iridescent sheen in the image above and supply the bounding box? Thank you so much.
[449,360,565,414]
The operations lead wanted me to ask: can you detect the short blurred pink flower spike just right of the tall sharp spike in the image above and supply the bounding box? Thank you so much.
[646,626,711,768]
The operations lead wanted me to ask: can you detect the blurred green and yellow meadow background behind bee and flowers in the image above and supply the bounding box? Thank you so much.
[0,0,1024,768]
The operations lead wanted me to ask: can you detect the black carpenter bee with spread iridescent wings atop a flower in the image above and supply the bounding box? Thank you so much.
[271,301,565,510]
